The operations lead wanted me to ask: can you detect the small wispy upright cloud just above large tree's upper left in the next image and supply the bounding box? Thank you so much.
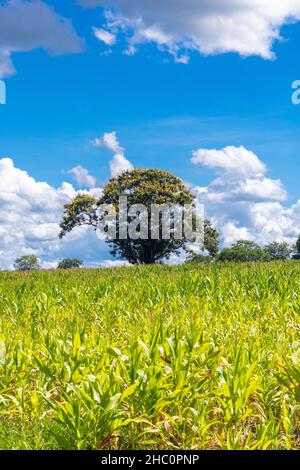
[91,131,133,177]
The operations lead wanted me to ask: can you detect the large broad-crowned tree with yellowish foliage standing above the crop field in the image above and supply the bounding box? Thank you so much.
[60,169,218,264]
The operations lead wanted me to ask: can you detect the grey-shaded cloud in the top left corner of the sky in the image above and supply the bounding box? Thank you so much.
[0,0,82,77]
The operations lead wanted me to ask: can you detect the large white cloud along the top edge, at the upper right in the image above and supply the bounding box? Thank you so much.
[77,0,300,63]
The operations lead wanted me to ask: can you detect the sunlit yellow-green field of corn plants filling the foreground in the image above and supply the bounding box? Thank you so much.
[0,262,300,450]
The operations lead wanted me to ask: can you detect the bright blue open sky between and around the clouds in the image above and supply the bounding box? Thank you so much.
[0,0,300,263]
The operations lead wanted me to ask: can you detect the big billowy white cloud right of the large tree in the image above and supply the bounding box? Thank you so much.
[191,146,300,245]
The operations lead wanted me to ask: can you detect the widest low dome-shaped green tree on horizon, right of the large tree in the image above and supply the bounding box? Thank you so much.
[218,240,270,263]
